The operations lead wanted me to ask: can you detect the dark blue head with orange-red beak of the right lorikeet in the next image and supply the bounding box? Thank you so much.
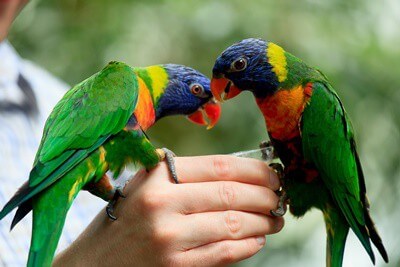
[211,38,279,99]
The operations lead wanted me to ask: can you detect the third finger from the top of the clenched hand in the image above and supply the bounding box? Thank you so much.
[179,210,284,248]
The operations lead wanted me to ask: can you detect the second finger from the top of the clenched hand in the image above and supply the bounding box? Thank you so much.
[176,181,279,215]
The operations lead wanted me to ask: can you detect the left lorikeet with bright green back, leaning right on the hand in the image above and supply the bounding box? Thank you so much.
[0,62,220,266]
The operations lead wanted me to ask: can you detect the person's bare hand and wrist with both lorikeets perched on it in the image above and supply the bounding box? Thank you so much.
[53,155,284,266]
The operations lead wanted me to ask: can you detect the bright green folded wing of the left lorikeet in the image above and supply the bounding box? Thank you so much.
[0,62,138,219]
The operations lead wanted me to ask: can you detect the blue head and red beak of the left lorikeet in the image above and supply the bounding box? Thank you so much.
[156,64,221,128]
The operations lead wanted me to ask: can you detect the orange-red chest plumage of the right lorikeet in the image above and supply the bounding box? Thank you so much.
[256,83,312,141]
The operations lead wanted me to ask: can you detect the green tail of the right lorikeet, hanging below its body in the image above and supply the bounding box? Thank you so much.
[323,208,349,267]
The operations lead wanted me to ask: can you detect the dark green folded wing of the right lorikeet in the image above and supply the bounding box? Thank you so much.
[301,83,375,262]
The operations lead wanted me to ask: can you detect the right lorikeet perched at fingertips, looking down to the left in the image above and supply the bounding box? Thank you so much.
[211,39,388,266]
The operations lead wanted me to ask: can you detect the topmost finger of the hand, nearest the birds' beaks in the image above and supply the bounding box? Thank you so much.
[155,155,280,190]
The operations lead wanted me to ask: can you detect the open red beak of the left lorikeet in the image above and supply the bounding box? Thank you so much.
[187,98,221,130]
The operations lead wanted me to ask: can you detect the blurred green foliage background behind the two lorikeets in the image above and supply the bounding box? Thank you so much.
[9,0,400,266]
